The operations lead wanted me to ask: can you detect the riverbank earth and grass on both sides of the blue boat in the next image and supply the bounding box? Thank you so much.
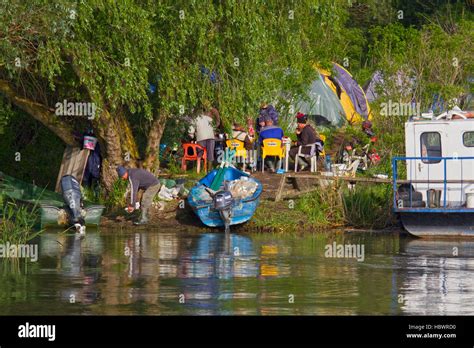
[100,179,398,233]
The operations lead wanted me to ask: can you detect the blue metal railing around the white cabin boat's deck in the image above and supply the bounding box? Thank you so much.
[392,156,474,212]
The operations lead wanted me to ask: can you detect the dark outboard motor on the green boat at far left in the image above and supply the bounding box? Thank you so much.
[61,175,86,233]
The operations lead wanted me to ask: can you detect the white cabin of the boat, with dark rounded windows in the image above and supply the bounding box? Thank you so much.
[405,118,474,208]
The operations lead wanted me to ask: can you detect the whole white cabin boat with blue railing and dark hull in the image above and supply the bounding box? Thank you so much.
[392,111,474,237]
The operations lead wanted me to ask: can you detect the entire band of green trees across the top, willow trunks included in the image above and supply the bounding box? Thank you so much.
[0,0,473,190]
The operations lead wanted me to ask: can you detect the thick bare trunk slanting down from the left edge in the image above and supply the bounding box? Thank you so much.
[0,80,77,146]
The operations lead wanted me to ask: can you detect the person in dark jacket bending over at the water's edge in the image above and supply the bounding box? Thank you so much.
[117,166,161,225]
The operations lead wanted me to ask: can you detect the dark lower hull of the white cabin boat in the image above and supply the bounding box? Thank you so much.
[400,212,474,237]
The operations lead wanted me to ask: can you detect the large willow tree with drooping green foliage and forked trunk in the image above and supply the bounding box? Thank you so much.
[0,0,348,190]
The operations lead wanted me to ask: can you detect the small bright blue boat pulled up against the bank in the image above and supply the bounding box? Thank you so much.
[188,167,262,227]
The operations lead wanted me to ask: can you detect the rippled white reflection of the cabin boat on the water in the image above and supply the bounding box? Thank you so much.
[400,240,474,315]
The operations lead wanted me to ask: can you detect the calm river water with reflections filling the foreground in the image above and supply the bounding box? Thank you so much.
[0,227,474,315]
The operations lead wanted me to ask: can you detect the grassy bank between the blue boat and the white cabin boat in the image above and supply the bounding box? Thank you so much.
[249,184,396,232]
